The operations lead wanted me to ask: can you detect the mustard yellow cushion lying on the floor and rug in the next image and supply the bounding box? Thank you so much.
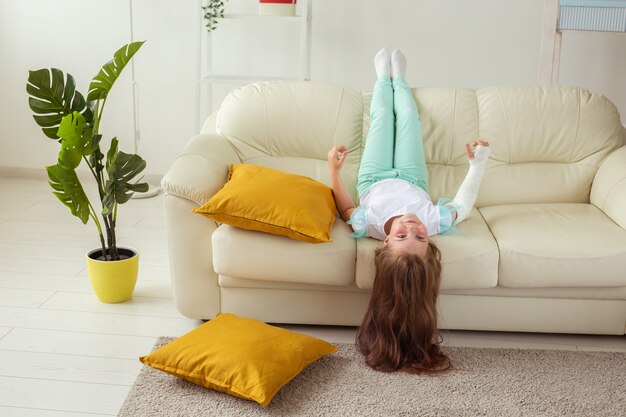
[139,314,337,407]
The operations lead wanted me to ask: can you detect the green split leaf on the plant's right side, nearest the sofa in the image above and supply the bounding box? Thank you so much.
[104,139,148,210]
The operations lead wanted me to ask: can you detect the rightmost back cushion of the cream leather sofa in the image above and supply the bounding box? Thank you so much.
[476,86,624,207]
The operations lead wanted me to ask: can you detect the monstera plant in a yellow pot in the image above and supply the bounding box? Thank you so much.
[26,42,148,303]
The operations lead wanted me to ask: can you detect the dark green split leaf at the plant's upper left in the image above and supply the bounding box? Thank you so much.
[26,68,93,139]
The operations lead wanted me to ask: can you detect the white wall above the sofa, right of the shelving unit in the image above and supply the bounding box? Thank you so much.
[312,0,626,110]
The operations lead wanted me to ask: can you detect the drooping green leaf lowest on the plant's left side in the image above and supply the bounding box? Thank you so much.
[46,164,89,223]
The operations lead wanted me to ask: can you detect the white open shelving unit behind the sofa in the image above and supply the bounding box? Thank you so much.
[196,0,313,130]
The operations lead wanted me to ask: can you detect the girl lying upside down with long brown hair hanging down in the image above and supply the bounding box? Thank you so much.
[328,48,490,374]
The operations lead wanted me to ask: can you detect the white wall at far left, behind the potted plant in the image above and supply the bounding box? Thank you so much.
[0,0,133,173]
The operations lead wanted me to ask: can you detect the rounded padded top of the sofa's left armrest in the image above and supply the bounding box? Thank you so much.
[161,133,241,205]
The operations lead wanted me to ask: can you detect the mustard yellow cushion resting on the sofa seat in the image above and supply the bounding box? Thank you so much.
[194,164,337,243]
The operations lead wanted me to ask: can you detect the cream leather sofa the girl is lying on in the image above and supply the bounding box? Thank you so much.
[162,82,626,335]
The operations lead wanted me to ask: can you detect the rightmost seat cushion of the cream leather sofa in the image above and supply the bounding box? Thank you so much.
[480,203,626,288]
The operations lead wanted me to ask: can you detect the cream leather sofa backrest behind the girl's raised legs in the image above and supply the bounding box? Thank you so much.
[216,82,626,206]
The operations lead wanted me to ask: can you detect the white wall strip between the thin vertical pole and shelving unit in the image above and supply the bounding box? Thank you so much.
[126,0,200,175]
